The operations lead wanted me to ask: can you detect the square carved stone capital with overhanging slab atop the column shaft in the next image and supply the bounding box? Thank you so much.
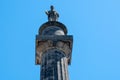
[36,35,73,64]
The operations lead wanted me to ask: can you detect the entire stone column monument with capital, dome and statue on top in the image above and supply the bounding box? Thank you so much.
[36,6,73,80]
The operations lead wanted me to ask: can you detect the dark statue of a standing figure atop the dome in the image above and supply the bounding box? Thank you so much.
[45,6,59,21]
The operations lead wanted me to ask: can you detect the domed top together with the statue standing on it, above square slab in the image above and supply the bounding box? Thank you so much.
[39,6,67,35]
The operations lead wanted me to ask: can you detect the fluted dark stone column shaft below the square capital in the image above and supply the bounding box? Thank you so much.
[41,49,68,80]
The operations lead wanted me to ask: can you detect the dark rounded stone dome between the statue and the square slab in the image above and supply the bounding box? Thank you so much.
[39,21,67,35]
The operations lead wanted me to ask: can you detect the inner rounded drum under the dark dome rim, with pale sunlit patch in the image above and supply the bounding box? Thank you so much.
[42,26,65,35]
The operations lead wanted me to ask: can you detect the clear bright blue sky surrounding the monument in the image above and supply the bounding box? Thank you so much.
[0,0,120,80]
